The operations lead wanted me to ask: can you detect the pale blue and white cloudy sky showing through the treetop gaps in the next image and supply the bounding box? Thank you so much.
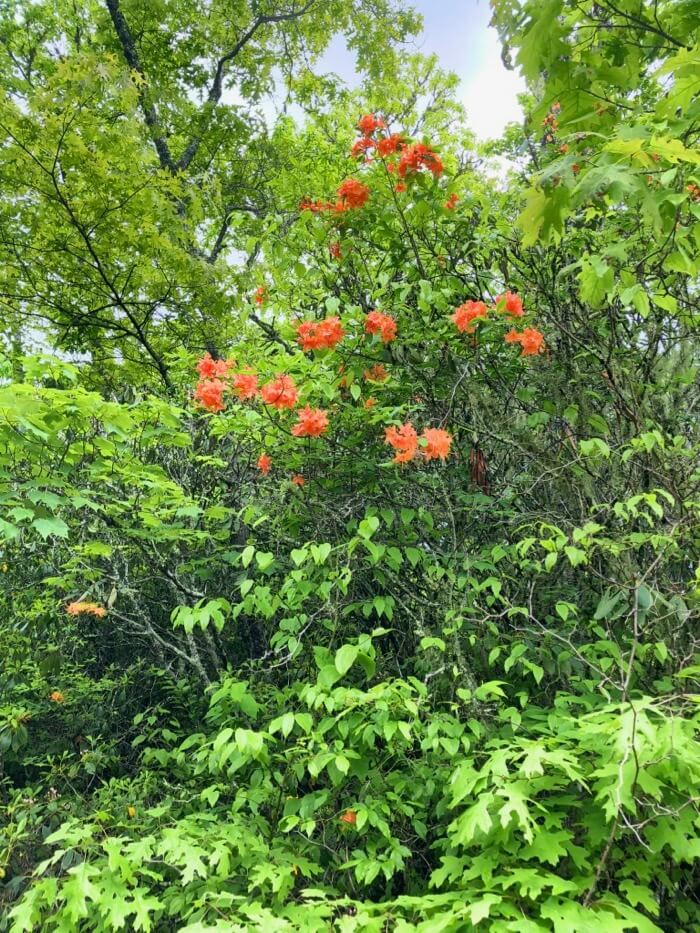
[322,0,525,140]
